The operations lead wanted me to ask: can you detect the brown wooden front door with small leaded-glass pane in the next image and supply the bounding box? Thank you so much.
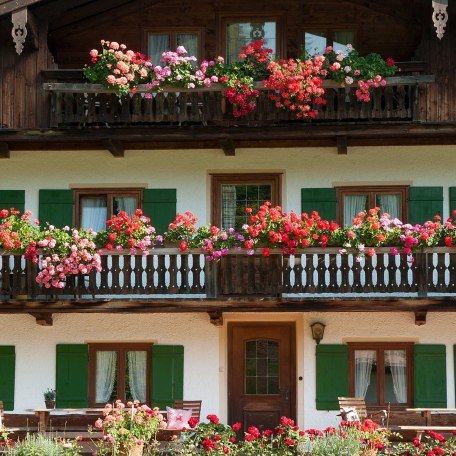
[228,322,296,430]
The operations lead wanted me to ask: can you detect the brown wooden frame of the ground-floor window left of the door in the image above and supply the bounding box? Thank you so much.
[88,342,153,407]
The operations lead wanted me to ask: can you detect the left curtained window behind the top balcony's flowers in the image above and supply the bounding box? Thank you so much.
[147,29,201,65]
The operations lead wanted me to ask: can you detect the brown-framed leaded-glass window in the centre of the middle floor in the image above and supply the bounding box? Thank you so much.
[212,174,281,231]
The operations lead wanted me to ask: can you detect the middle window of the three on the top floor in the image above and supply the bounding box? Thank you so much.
[220,16,283,63]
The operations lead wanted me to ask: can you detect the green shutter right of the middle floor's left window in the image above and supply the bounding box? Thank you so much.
[143,188,177,234]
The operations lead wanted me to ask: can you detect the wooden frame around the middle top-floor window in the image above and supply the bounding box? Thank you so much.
[217,11,287,59]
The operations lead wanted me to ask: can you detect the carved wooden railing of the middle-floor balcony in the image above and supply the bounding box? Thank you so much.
[0,247,456,301]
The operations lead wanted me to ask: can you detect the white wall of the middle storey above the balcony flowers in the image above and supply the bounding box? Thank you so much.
[0,146,456,223]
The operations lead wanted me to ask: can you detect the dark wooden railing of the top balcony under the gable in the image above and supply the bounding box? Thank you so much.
[43,75,434,127]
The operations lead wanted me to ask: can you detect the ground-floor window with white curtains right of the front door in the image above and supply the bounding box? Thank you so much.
[349,343,413,406]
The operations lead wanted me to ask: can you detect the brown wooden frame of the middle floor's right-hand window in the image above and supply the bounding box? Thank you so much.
[336,185,410,226]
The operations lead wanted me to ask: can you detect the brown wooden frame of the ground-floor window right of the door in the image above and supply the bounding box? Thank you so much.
[347,342,414,409]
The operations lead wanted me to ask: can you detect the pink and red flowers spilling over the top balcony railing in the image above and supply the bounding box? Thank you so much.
[84,40,397,119]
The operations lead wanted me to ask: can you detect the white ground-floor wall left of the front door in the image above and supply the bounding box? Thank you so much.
[0,313,219,416]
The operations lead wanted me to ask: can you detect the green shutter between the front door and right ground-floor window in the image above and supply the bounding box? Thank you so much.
[316,345,348,410]
